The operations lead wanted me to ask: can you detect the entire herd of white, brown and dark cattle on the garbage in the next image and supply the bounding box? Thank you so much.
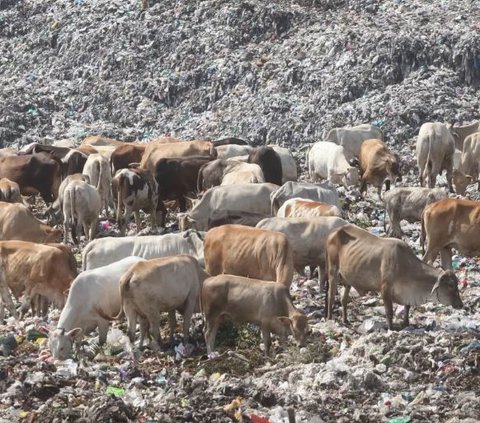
[0,122,480,359]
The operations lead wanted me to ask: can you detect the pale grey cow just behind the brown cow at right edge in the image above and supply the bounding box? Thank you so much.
[383,187,448,238]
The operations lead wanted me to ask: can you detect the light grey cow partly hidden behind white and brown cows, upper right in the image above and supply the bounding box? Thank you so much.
[324,124,383,161]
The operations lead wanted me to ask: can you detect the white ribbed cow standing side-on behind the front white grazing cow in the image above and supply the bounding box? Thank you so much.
[82,229,205,270]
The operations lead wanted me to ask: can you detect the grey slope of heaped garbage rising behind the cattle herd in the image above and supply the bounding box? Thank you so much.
[0,0,480,146]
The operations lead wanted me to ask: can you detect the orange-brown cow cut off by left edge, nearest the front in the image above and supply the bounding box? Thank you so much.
[0,241,77,319]
